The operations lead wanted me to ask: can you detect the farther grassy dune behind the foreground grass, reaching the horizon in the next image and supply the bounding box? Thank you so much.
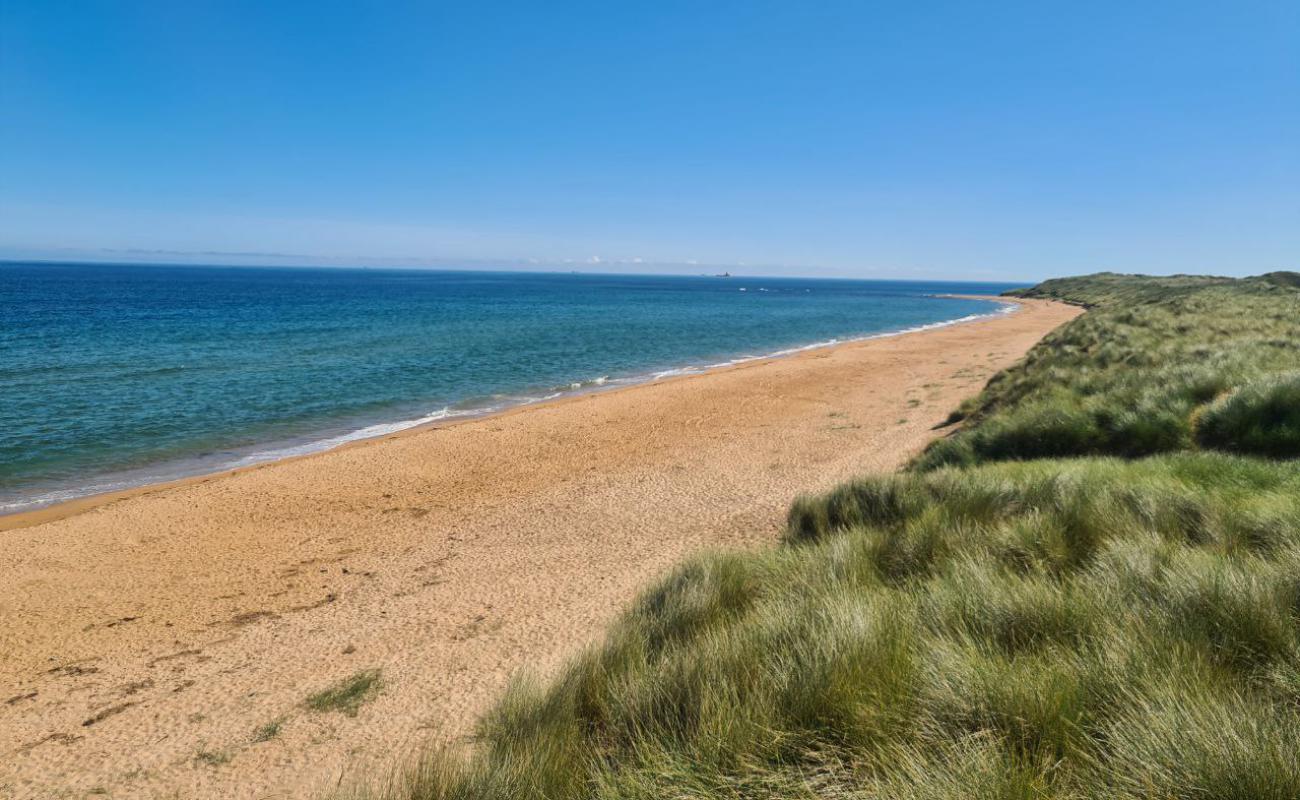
[917,273,1300,470]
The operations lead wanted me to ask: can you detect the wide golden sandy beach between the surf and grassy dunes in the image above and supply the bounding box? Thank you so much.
[0,302,1079,800]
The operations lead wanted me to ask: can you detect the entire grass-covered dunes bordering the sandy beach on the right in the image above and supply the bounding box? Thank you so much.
[379,274,1300,800]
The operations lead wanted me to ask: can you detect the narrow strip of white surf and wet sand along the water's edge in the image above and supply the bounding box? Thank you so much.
[0,294,1022,533]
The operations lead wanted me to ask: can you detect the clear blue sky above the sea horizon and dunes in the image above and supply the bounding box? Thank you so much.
[0,0,1300,280]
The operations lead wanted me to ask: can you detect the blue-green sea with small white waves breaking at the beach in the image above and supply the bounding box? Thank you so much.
[0,263,1009,513]
